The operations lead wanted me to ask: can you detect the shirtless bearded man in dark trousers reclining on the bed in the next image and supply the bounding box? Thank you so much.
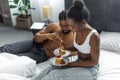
[1,11,73,63]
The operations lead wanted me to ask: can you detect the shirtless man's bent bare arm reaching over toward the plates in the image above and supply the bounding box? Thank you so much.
[34,23,61,42]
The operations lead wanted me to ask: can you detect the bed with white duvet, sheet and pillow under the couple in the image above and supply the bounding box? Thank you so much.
[0,31,120,80]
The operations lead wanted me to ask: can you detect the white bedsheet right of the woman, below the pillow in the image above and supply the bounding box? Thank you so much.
[98,50,120,80]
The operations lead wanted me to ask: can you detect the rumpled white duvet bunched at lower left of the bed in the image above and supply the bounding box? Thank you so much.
[0,53,36,80]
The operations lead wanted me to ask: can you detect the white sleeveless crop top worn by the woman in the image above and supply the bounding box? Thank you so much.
[73,29,97,54]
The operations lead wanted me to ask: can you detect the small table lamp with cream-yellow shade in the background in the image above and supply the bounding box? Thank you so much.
[43,5,52,24]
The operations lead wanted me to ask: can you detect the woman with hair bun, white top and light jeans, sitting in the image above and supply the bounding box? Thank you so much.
[31,0,100,80]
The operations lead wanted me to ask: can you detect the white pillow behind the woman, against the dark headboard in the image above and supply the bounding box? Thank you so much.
[100,31,120,52]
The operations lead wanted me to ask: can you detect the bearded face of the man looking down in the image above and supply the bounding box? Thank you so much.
[60,20,71,34]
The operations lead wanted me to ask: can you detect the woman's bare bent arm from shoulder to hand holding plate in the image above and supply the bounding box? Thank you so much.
[66,33,100,67]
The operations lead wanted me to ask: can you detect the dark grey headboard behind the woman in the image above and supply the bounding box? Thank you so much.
[84,0,120,32]
